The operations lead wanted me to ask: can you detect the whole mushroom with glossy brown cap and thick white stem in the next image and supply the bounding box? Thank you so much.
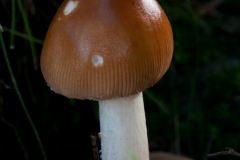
[41,0,173,160]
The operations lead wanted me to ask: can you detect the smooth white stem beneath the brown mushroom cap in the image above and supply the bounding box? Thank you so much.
[99,93,149,160]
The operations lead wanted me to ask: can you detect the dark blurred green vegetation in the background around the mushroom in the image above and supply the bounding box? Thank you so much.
[0,0,240,160]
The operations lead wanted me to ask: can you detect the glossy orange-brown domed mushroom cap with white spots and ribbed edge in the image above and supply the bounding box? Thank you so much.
[41,0,173,100]
